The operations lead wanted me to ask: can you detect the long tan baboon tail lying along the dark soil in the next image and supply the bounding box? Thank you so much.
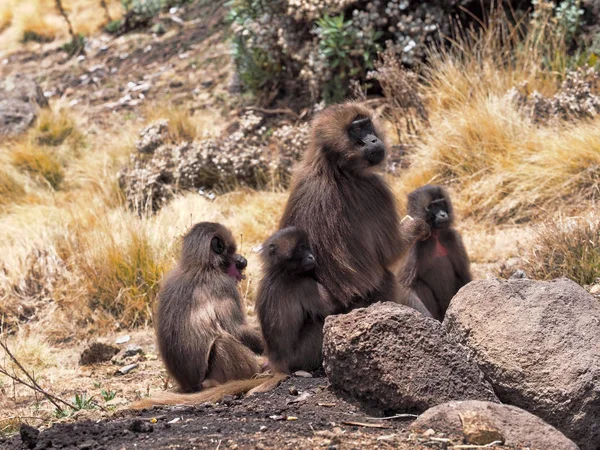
[130,373,288,410]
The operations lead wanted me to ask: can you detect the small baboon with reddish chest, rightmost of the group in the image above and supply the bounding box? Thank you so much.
[399,185,472,321]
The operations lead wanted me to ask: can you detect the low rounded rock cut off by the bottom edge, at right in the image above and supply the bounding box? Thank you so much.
[412,400,578,450]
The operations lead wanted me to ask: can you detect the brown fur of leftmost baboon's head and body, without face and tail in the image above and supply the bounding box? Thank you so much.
[156,222,264,392]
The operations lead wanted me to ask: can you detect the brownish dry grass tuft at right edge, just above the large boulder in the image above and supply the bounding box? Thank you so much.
[523,213,600,285]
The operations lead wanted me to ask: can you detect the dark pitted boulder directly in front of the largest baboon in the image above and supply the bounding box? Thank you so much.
[323,303,497,412]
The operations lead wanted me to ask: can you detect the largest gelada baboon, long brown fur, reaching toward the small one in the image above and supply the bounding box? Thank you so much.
[280,103,429,314]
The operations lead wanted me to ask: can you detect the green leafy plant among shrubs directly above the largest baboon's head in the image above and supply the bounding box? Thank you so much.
[316,14,382,102]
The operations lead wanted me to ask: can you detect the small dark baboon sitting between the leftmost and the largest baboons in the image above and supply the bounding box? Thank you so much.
[256,227,333,373]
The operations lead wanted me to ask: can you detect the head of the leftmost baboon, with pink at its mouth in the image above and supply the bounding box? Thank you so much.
[181,222,248,281]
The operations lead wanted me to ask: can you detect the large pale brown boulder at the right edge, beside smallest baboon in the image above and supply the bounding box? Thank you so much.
[443,278,600,450]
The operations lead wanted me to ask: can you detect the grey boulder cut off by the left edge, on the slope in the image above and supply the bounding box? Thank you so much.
[0,75,48,136]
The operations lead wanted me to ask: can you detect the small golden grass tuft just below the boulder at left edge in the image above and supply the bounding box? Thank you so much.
[11,144,64,190]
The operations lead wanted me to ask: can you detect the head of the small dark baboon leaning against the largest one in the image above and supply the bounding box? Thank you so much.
[263,227,317,275]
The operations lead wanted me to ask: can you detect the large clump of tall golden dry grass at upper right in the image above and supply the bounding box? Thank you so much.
[401,8,600,223]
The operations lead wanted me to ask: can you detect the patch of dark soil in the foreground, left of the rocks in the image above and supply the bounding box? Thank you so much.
[0,377,440,450]
